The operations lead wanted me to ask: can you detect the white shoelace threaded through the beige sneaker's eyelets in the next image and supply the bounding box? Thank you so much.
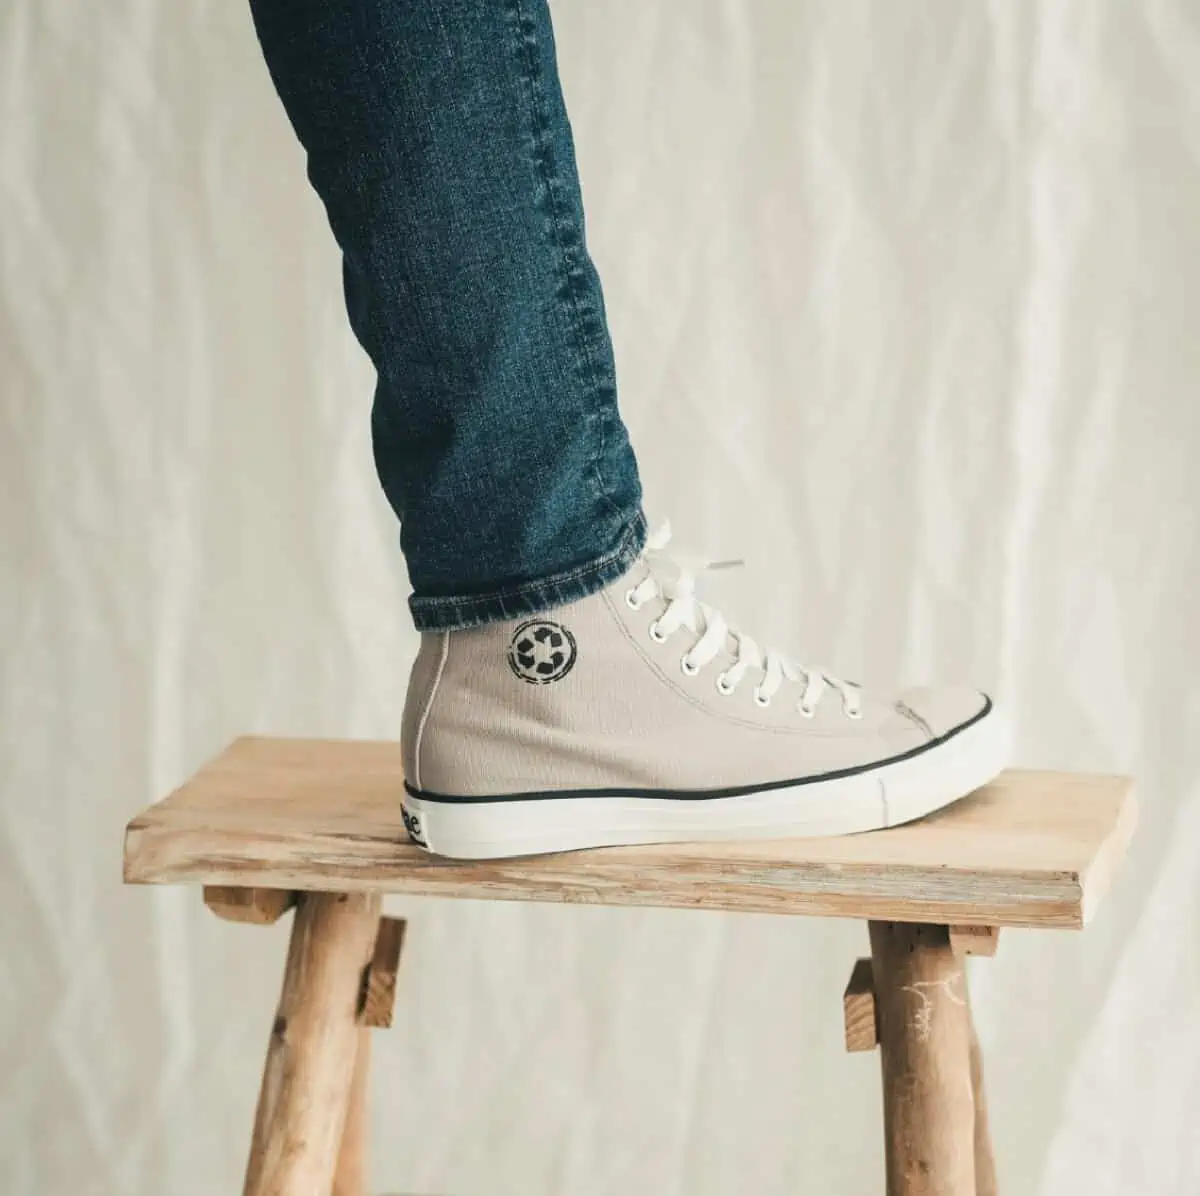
[625,523,863,719]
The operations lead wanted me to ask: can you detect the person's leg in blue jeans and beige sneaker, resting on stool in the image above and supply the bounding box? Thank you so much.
[252,0,1008,858]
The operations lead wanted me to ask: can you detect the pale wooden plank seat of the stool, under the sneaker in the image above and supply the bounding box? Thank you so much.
[125,738,1136,927]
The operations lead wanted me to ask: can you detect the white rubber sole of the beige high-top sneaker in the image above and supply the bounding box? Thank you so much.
[403,707,1010,860]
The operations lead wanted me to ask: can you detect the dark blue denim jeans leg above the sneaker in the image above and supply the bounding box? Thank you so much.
[244,0,646,630]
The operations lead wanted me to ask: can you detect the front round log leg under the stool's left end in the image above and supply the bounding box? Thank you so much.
[245,893,379,1196]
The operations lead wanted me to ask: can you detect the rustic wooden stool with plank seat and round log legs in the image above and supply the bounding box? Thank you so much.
[125,739,1136,1196]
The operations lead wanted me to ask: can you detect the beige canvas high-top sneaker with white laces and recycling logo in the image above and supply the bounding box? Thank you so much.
[402,527,1009,859]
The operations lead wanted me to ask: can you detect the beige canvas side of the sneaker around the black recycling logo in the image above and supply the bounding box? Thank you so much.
[403,583,926,797]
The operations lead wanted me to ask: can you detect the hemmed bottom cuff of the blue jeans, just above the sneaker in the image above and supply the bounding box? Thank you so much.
[408,515,646,631]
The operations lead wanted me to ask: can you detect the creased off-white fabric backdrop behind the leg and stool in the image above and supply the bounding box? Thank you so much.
[0,0,1200,1196]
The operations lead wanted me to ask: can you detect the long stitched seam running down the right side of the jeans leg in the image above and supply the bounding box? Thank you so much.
[509,0,622,519]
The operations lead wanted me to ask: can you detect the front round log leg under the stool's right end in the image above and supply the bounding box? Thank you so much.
[870,921,976,1196]
